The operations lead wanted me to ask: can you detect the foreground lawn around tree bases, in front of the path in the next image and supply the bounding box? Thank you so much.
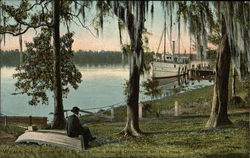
[0,114,250,158]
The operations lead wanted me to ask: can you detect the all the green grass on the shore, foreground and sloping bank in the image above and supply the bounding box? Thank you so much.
[0,79,250,158]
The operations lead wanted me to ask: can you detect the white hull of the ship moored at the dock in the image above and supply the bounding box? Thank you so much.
[151,61,187,79]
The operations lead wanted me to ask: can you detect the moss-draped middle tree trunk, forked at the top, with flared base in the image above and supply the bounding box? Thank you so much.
[117,1,145,136]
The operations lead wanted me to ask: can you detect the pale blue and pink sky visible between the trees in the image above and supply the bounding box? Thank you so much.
[2,0,190,53]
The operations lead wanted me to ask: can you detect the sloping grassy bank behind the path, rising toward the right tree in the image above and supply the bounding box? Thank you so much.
[115,86,250,120]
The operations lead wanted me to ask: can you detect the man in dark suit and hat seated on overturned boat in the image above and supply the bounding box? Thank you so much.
[66,106,95,149]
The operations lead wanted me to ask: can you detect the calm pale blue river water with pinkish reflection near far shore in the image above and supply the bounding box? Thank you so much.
[1,65,213,120]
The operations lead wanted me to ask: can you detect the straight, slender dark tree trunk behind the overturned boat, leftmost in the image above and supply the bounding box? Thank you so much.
[52,0,65,129]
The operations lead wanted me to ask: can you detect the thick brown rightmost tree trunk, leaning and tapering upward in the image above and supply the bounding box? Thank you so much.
[206,17,232,128]
